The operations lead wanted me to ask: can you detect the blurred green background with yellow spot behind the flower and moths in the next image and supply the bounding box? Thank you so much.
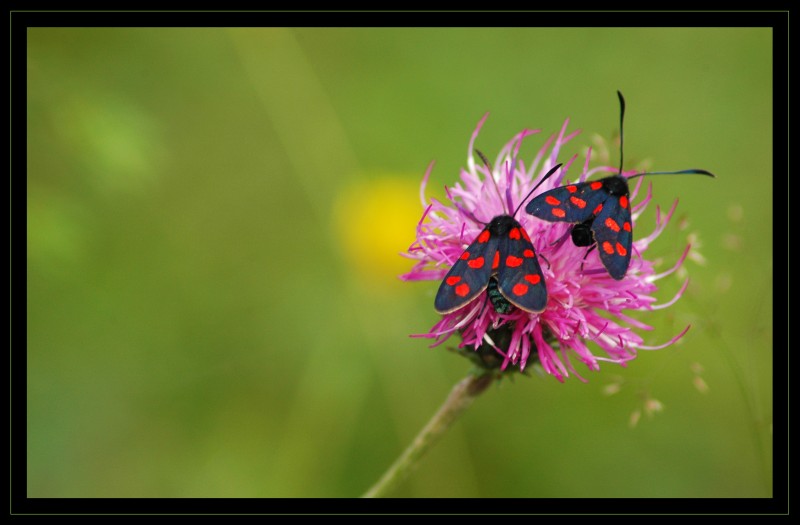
[27,28,772,497]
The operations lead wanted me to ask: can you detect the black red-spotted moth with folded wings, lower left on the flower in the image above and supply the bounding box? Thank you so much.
[434,164,561,314]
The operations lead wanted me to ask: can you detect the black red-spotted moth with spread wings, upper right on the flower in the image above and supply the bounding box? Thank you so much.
[525,91,714,280]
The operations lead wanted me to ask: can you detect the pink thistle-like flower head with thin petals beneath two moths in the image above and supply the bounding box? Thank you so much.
[400,114,690,382]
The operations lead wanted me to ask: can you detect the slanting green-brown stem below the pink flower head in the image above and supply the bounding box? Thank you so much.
[362,373,496,498]
